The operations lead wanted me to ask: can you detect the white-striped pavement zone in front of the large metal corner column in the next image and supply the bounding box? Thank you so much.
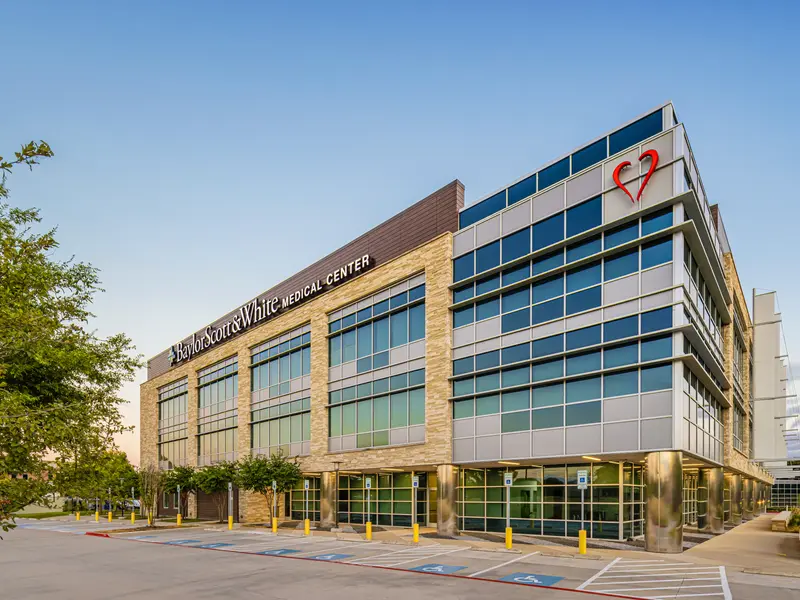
[578,558,731,600]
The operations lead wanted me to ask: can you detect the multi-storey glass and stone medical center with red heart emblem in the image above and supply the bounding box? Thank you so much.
[141,103,773,552]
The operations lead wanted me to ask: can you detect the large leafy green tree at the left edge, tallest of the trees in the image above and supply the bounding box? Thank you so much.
[0,142,141,530]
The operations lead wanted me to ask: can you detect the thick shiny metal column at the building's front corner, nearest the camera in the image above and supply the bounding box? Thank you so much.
[644,451,683,553]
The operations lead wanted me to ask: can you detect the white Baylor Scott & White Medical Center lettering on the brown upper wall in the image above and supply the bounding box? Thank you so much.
[169,254,372,366]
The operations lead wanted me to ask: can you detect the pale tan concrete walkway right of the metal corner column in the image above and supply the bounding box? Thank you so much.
[682,514,800,577]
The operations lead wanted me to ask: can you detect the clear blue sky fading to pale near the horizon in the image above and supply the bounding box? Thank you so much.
[0,0,800,462]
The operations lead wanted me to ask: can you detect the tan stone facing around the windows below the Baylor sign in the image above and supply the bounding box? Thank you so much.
[140,233,452,521]
